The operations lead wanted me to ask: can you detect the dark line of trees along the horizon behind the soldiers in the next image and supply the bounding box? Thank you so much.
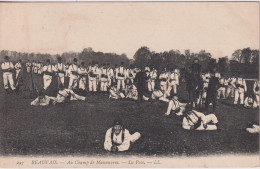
[0,46,259,75]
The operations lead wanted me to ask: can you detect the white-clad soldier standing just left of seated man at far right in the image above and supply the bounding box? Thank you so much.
[234,75,247,105]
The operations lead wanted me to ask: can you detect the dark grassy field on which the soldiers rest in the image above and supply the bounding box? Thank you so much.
[0,69,259,156]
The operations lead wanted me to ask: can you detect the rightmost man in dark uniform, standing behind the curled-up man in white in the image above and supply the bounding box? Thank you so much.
[205,70,219,113]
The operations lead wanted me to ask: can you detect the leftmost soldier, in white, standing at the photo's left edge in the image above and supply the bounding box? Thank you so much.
[1,56,16,93]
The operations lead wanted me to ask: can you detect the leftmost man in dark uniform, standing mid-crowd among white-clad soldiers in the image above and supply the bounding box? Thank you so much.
[134,68,148,103]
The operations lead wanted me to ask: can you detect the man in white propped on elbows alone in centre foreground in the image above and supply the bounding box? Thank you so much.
[104,120,141,152]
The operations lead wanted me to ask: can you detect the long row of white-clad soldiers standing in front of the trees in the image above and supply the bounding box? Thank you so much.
[1,56,260,108]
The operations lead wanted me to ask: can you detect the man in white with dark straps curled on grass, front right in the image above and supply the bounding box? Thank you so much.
[182,107,218,130]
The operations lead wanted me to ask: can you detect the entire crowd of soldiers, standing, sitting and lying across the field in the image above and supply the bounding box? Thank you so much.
[1,56,260,151]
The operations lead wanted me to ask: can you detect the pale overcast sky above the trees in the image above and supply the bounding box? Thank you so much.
[0,2,259,58]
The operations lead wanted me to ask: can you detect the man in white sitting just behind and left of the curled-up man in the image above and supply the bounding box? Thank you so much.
[164,94,187,116]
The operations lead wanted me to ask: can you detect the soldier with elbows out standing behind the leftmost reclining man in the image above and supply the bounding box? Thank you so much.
[42,59,56,90]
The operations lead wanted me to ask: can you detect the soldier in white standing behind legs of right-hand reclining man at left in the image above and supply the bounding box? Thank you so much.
[68,58,79,89]
